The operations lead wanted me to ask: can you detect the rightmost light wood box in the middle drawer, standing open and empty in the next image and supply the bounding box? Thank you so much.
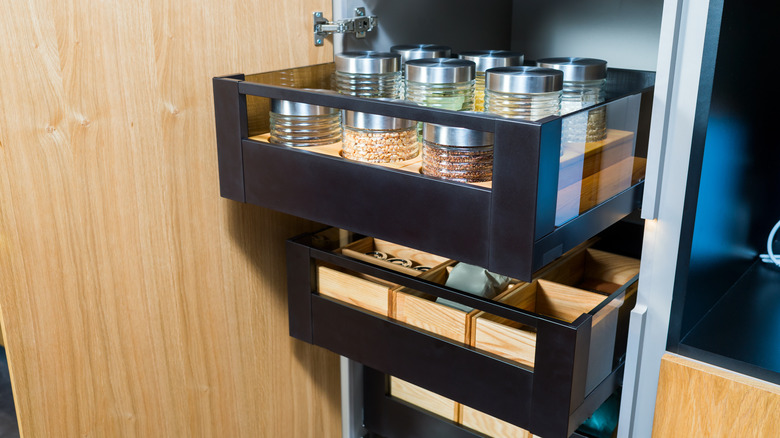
[470,242,639,374]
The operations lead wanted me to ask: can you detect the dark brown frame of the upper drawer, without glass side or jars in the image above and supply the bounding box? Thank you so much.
[213,67,655,280]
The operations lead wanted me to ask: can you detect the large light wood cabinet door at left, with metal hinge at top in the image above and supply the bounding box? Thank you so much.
[0,0,340,437]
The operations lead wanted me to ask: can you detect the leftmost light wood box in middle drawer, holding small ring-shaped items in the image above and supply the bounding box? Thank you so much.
[317,237,447,316]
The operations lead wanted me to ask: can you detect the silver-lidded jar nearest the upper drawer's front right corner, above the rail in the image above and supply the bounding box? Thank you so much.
[485,66,563,120]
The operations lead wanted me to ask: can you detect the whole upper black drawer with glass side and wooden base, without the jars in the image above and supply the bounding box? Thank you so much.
[214,64,654,281]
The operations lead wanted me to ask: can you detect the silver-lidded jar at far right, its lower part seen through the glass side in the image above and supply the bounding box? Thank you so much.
[537,58,607,143]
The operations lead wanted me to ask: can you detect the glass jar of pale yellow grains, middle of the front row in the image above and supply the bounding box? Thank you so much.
[341,111,420,163]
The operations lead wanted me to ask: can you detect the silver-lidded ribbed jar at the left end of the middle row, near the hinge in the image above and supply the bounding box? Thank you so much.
[334,51,401,99]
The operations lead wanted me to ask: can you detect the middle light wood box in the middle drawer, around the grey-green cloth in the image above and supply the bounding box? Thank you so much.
[391,261,523,344]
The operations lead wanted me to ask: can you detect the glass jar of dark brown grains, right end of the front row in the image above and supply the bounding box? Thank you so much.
[421,123,493,182]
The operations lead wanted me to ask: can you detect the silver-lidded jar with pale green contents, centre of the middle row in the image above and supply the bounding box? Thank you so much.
[405,58,475,111]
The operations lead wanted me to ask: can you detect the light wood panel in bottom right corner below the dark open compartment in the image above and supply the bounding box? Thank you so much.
[653,354,780,438]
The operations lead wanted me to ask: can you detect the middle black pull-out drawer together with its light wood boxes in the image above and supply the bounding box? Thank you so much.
[287,229,639,438]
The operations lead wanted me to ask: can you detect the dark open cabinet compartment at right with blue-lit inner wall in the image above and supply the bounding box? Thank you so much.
[668,1,780,383]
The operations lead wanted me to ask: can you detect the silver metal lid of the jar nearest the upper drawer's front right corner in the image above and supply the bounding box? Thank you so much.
[485,66,563,93]
